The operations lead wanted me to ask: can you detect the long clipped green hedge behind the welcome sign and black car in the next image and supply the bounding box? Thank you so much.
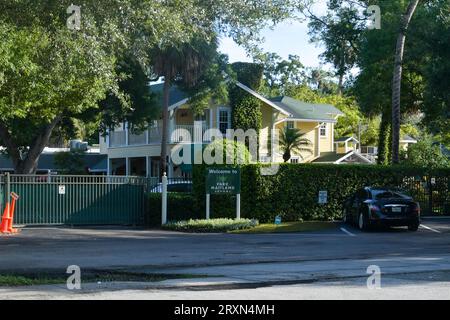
[194,164,450,222]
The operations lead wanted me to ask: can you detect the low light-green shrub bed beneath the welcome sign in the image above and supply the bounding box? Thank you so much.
[163,218,258,232]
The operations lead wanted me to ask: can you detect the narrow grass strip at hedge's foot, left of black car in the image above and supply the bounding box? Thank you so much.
[231,221,337,233]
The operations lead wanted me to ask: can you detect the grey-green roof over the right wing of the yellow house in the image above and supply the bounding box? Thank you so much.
[270,96,343,122]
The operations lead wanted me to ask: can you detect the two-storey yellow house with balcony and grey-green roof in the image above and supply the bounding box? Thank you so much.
[100,82,368,177]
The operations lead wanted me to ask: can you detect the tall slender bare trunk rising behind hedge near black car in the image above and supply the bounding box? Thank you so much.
[392,0,420,164]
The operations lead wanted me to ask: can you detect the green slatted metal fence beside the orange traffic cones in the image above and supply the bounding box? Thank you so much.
[0,175,157,225]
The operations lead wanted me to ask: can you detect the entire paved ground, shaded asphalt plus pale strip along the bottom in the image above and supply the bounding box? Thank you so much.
[0,219,450,299]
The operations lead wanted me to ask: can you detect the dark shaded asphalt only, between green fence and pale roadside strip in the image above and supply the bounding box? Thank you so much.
[0,220,450,270]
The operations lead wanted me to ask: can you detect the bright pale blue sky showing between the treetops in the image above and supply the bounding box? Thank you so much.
[219,0,328,69]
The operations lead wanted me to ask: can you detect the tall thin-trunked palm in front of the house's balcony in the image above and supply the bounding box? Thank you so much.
[150,36,218,176]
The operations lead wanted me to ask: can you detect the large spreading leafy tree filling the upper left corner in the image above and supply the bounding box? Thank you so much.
[0,0,310,173]
